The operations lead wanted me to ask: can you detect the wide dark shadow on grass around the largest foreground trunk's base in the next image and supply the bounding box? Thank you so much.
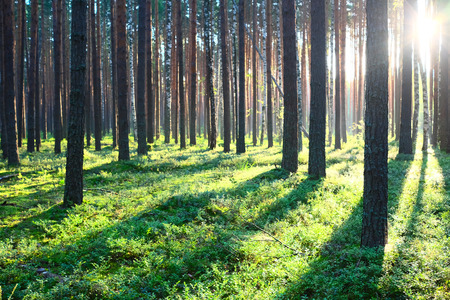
[278,154,412,299]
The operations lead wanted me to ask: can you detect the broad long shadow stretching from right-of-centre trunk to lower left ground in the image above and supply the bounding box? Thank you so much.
[0,166,287,299]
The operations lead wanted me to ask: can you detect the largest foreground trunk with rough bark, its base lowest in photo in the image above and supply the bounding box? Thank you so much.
[361,0,389,247]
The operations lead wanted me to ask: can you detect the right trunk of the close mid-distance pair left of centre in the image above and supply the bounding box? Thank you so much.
[137,0,147,155]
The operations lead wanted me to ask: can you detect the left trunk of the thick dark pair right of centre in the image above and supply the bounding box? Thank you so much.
[281,0,298,172]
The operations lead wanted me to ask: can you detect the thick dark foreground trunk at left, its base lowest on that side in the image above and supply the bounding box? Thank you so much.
[64,0,87,207]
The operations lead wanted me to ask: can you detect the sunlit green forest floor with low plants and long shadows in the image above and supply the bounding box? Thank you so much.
[0,138,450,299]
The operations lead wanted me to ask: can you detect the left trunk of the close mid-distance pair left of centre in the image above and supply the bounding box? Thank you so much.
[116,0,130,160]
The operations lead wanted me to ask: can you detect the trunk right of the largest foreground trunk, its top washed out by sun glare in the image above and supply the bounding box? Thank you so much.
[399,0,417,154]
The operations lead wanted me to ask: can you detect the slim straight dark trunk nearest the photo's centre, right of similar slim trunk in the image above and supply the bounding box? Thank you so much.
[236,0,246,154]
